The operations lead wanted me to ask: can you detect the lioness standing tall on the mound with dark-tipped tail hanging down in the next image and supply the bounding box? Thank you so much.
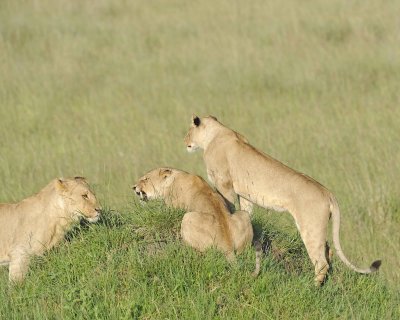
[184,116,381,285]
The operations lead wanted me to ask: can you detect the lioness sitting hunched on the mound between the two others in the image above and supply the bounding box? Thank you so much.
[133,168,260,275]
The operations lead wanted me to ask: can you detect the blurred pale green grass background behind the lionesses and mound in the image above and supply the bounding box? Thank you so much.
[0,0,400,284]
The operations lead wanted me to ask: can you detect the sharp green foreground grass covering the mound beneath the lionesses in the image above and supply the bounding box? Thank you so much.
[0,203,400,319]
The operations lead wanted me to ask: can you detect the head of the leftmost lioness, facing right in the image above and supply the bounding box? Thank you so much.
[55,177,101,222]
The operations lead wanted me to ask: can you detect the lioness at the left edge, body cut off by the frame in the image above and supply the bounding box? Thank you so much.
[0,177,101,282]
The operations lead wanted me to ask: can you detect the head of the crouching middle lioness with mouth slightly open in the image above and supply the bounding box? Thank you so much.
[132,168,173,201]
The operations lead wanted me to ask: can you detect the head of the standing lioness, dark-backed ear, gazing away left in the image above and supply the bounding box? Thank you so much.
[184,115,219,152]
